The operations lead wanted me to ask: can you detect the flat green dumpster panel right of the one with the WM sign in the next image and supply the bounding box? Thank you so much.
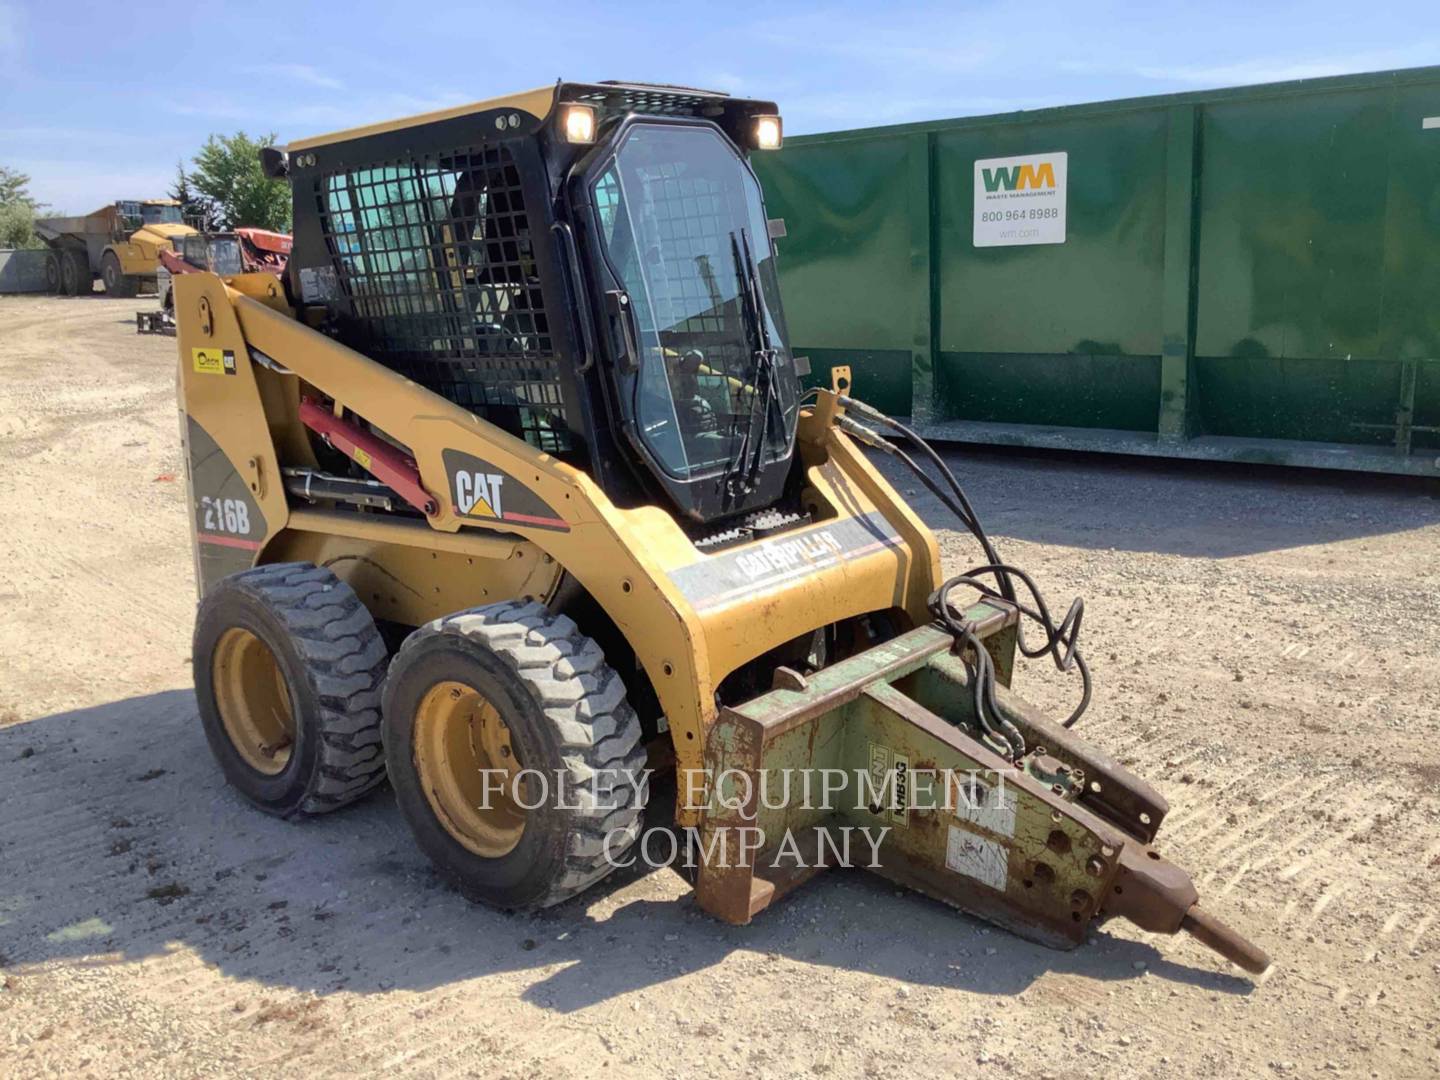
[1195,89,1393,445]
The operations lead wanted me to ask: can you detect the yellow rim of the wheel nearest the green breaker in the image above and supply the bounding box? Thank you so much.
[415,681,530,858]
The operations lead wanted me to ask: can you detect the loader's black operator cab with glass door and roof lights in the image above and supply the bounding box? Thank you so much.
[275,82,799,540]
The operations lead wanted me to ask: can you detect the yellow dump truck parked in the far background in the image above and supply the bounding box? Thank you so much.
[35,199,196,297]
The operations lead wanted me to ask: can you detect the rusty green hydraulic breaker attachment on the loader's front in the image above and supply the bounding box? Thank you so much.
[696,599,1270,972]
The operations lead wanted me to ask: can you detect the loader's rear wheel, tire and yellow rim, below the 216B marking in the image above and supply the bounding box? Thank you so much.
[194,563,386,818]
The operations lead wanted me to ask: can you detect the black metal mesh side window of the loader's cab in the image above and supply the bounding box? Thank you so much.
[315,145,570,452]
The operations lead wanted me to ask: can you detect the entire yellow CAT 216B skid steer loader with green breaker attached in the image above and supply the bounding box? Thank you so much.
[174,82,1269,971]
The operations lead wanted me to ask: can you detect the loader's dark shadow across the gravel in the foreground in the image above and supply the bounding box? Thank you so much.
[0,690,1250,1012]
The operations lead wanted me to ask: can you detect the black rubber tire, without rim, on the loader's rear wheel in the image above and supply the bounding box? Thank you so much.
[194,563,389,818]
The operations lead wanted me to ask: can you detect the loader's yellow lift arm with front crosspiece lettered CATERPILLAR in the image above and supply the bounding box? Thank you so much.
[174,274,939,824]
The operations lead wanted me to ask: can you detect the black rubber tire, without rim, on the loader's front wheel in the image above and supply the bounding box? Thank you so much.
[384,600,649,910]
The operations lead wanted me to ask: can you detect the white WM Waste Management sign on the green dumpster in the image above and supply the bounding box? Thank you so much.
[975,151,1067,248]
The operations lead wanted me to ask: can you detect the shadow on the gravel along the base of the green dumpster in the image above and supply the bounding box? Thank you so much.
[878,444,1440,559]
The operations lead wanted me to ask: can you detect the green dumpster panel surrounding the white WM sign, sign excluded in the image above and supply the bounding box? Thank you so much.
[935,109,1166,431]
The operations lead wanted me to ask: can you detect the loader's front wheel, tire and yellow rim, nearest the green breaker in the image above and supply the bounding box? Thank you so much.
[384,602,649,909]
